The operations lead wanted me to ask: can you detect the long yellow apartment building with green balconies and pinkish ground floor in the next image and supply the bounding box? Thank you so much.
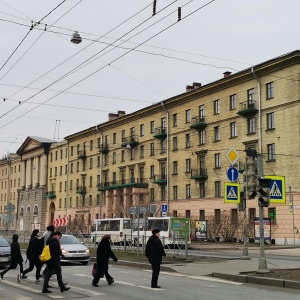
[10,50,300,243]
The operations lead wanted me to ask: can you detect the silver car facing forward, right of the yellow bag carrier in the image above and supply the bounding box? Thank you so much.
[60,234,90,265]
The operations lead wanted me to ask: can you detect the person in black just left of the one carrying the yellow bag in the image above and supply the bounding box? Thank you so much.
[21,229,44,283]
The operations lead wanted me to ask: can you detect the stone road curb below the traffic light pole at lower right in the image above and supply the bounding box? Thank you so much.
[212,272,300,289]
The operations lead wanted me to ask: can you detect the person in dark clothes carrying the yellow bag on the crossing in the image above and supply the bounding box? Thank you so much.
[42,231,70,293]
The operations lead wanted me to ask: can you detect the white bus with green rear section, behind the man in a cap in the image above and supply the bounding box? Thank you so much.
[132,217,191,246]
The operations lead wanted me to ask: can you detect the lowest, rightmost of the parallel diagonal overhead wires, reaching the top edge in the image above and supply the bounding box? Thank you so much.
[0,0,215,129]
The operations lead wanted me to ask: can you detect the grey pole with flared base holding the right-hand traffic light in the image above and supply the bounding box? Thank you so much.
[256,154,270,274]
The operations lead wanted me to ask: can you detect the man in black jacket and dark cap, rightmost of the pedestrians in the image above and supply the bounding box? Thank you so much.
[145,228,166,289]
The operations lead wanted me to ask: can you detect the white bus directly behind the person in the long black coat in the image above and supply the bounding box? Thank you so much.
[91,218,132,244]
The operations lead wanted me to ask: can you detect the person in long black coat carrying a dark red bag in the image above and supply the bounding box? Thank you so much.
[92,234,118,287]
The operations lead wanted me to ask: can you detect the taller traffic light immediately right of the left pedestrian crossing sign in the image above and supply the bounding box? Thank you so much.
[243,156,257,199]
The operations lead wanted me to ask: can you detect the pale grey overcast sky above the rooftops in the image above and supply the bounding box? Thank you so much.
[0,0,300,158]
